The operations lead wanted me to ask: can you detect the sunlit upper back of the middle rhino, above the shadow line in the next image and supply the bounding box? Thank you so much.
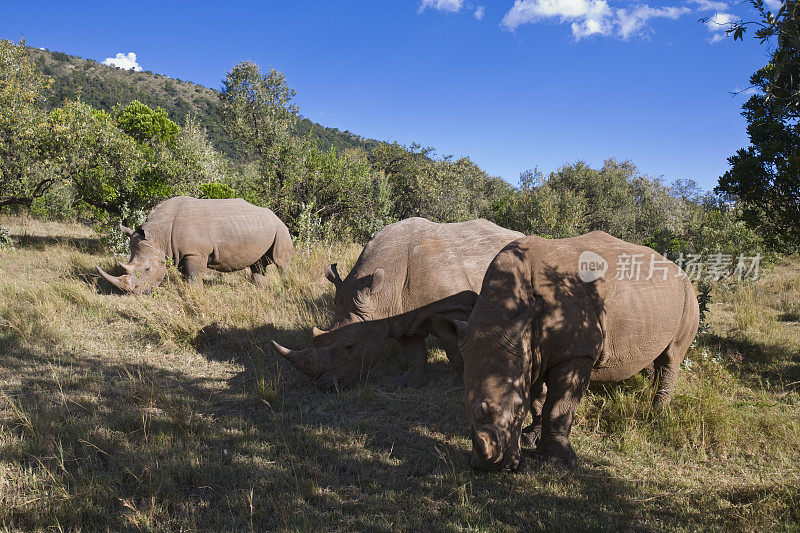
[336,218,522,318]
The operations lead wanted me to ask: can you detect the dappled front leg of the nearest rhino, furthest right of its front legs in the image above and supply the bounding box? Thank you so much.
[534,357,594,467]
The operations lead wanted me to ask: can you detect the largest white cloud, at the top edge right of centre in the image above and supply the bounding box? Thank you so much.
[502,0,691,39]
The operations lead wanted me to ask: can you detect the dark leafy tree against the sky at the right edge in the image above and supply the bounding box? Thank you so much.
[715,0,800,250]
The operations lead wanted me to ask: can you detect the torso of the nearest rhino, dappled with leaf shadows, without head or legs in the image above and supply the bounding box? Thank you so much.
[476,232,691,381]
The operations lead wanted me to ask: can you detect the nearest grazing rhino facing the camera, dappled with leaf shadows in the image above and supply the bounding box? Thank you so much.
[437,231,699,470]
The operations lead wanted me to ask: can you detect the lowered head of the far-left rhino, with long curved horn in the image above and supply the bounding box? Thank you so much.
[97,224,167,294]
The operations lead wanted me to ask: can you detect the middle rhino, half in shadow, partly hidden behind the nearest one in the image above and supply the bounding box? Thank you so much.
[273,218,522,391]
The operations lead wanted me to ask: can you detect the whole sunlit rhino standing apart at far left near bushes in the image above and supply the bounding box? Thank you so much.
[97,196,292,294]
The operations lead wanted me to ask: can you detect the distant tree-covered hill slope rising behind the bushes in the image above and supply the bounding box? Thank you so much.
[29,47,378,158]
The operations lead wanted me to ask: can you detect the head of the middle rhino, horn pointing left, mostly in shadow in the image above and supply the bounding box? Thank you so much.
[272,264,388,392]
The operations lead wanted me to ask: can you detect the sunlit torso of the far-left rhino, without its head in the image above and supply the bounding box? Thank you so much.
[148,197,283,272]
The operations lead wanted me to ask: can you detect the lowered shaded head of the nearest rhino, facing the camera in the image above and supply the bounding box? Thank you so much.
[436,312,533,471]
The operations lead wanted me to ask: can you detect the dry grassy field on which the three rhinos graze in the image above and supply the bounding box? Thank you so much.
[0,218,800,531]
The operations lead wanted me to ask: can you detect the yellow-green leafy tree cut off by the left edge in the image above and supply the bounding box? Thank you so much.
[0,39,55,207]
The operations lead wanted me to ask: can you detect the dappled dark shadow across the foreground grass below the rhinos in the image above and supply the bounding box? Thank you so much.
[0,325,788,530]
